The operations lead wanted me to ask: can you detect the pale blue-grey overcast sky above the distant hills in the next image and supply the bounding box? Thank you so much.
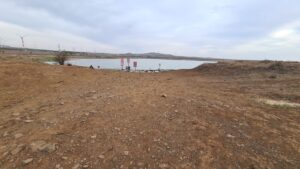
[0,0,300,61]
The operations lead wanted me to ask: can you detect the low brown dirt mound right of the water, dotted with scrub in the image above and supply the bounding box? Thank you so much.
[195,61,300,75]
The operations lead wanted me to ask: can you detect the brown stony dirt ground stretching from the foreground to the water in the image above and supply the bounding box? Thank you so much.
[0,60,300,169]
